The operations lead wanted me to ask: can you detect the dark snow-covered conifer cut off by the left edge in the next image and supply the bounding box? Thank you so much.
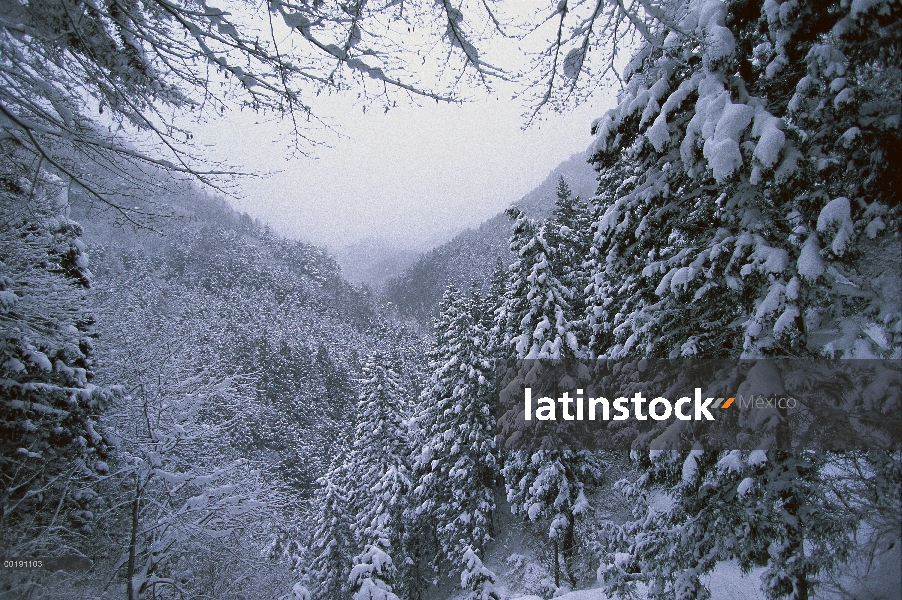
[0,177,114,555]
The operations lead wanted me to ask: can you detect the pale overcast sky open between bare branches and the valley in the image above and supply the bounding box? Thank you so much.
[187,34,612,250]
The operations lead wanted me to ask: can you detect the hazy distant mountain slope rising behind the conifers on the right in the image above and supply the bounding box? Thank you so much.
[383,152,597,327]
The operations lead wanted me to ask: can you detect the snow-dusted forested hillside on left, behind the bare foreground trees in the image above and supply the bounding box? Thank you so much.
[73,188,416,493]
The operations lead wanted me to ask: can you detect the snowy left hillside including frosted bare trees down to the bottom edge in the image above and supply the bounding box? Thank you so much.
[0,172,428,598]
